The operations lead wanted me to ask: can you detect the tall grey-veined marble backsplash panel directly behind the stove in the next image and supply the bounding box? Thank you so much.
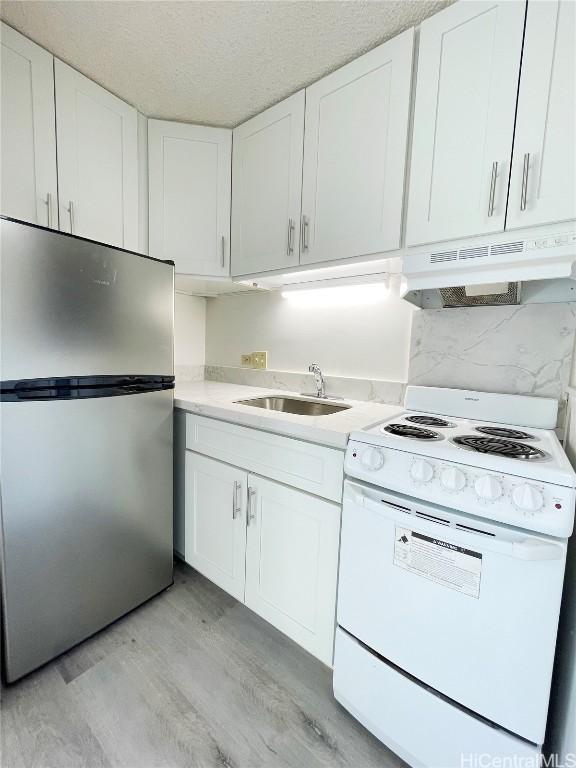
[408,303,576,426]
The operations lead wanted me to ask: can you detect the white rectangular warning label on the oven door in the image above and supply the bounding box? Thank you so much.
[394,526,482,598]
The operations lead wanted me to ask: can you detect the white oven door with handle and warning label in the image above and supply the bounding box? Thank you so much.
[338,480,566,744]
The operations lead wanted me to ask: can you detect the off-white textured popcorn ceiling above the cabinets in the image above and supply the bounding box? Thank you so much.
[0,0,451,126]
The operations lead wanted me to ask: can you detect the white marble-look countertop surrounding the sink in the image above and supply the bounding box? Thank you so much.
[174,381,404,449]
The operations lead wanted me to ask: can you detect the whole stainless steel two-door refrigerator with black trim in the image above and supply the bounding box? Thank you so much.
[0,217,174,682]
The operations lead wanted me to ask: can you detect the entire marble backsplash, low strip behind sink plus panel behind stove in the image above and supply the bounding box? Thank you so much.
[176,303,576,424]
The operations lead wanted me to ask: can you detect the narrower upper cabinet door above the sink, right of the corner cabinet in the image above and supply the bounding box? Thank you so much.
[232,91,304,275]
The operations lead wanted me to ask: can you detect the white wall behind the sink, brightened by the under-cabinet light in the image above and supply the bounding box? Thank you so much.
[206,292,413,381]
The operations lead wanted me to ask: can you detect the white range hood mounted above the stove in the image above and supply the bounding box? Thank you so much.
[401,221,576,309]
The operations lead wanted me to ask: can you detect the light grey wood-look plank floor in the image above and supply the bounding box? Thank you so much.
[1,563,403,768]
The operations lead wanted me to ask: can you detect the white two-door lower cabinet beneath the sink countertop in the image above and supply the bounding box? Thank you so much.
[180,414,343,665]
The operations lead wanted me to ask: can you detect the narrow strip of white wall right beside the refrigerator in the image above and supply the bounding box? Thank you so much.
[174,293,206,378]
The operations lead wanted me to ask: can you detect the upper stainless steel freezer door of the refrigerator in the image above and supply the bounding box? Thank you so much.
[0,219,174,381]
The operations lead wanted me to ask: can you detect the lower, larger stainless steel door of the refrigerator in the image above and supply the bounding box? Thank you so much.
[0,390,172,681]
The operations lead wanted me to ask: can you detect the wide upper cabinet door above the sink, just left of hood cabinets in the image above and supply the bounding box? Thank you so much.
[300,30,414,264]
